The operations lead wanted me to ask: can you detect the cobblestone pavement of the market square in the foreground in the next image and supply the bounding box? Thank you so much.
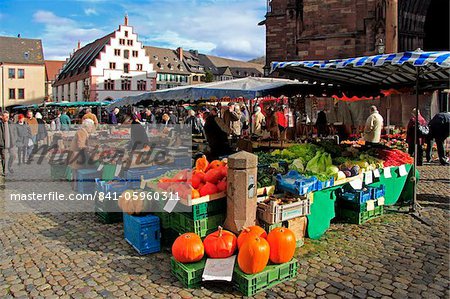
[0,166,450,298]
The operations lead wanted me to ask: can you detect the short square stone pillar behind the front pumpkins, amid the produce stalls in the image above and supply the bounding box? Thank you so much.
[224,151,258,233]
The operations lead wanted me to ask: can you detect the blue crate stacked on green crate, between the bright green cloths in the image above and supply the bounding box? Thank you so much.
[337,185,385,224]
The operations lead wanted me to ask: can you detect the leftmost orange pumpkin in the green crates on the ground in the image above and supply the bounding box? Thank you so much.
[172,233,205,263]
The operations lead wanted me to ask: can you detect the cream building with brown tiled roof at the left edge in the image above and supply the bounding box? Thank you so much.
[0,35,45,109]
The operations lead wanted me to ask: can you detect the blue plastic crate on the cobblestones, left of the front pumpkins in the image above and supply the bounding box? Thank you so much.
[123,213,161,255]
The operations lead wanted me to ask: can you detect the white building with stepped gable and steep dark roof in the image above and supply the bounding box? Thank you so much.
[53,16,156,102]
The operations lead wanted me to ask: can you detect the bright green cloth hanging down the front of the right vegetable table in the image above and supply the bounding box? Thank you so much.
[307,164,419,239]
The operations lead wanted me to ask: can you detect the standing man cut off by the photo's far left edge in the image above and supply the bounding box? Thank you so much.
[0,111,16,176]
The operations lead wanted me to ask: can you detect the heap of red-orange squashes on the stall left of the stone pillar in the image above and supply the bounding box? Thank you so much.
[157,156,228,199]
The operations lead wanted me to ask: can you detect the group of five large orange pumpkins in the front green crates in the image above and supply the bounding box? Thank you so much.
[172,225,296,274]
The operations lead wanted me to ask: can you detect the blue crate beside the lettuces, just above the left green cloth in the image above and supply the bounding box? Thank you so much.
[276,170,317,195]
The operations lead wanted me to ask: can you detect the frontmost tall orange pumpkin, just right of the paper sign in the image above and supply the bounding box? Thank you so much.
[238,234,270,274]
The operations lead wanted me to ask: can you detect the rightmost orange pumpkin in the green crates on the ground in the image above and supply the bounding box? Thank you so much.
[267,227,296,264]
